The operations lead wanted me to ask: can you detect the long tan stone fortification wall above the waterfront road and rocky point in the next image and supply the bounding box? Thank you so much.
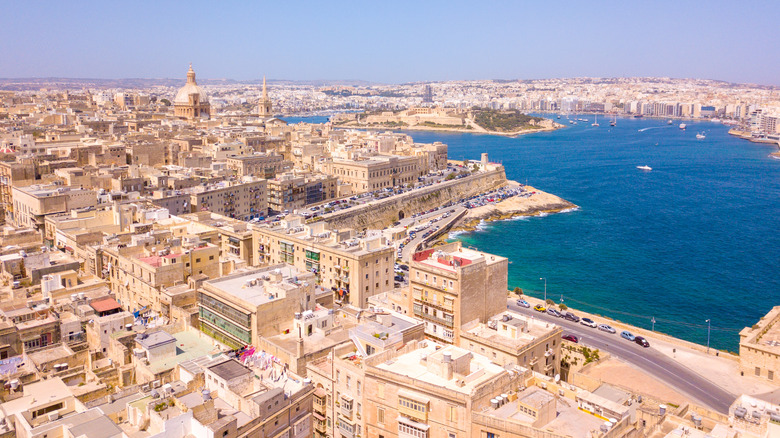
[322,166,507,230]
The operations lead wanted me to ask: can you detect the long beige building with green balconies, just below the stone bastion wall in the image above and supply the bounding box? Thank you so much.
[253,215,395,308]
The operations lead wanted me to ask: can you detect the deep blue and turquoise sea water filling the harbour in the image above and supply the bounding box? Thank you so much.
[408,116,780,351]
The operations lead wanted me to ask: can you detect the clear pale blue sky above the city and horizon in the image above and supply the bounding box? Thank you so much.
[0,0,780,85]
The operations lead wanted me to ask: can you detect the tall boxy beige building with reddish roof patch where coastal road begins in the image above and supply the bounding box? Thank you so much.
[407,242,509,345]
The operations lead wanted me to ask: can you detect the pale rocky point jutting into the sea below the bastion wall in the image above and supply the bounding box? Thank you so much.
[452,181,579,232]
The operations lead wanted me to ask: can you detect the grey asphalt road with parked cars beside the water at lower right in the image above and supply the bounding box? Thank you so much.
[507,299,737,415]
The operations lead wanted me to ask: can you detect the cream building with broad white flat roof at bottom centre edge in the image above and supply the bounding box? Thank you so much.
[364,341,521,438]
